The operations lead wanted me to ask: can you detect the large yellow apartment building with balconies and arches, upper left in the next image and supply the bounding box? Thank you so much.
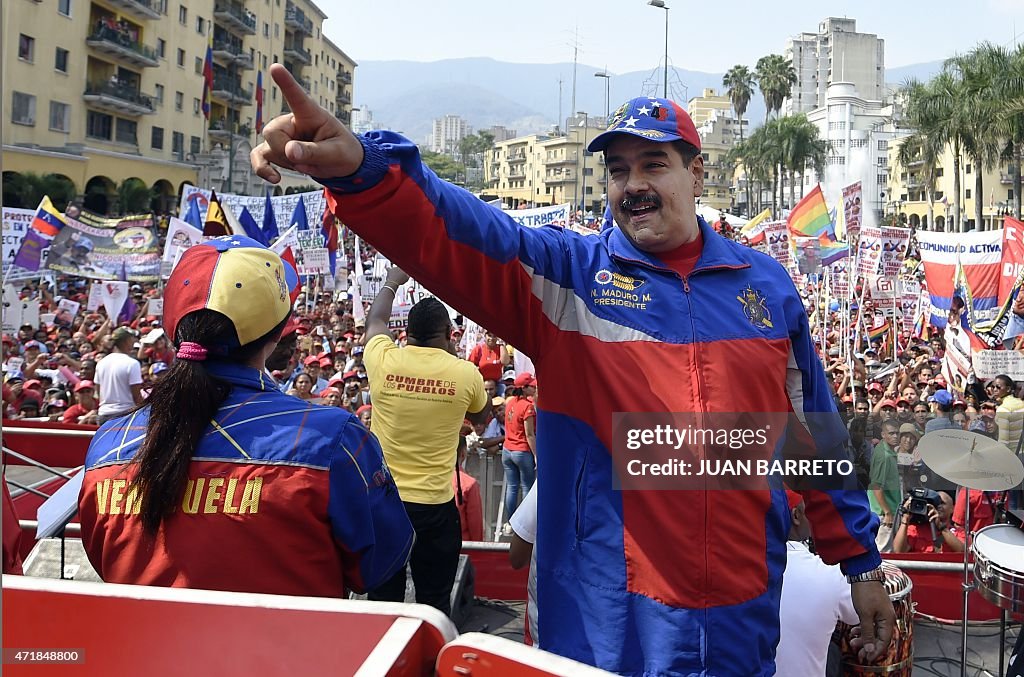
[2,0,355,214]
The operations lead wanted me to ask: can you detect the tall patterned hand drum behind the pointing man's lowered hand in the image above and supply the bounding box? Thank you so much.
[839,561,913,677]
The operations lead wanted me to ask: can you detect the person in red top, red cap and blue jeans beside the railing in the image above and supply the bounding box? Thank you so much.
[502,372,537,533]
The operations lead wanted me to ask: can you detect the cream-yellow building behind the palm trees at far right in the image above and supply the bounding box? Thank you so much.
[886,138,1014,230]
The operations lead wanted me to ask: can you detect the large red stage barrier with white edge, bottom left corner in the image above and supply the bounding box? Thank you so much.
[3,577,458,677]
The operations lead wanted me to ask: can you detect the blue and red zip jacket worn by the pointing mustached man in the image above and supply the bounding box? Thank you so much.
[325,131,881,677]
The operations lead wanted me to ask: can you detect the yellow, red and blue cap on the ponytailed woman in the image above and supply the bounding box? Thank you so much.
[164,236,299,345]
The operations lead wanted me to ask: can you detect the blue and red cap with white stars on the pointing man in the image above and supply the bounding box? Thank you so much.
[587,96,700,153]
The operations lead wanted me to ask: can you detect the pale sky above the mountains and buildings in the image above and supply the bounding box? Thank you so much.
[323,0,1024,73]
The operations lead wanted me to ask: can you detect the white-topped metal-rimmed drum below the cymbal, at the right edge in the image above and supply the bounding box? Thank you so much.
[971,524,1024,613]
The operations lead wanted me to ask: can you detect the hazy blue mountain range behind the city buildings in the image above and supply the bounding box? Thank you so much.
[354,57,942,142]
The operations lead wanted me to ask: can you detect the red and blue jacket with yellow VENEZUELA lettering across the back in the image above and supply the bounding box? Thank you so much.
[79,362,414,597]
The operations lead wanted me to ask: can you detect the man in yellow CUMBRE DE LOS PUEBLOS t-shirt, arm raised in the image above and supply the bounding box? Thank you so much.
[362,268,490,615]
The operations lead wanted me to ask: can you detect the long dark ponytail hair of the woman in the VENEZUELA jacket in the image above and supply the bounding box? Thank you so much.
[132,310,287,535]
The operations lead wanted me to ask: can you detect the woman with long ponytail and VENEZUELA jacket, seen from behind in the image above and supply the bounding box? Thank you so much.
[79,237,413,597]
